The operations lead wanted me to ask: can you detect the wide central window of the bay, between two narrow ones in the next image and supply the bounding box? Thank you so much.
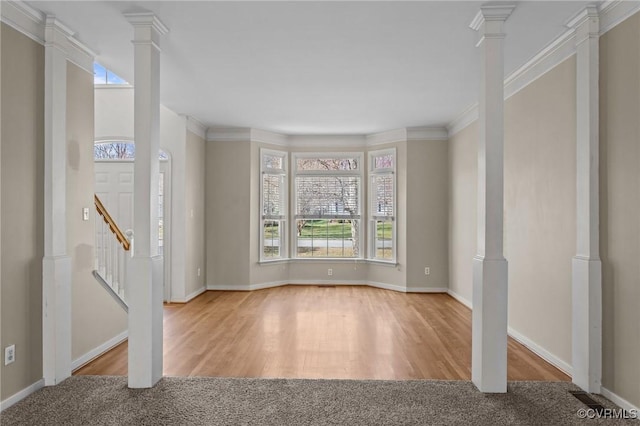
[292,153,363,258]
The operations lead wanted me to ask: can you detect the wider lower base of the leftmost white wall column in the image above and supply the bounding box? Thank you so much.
[42,256,71,386]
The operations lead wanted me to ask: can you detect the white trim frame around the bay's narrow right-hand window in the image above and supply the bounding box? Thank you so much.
[366,148,398,265]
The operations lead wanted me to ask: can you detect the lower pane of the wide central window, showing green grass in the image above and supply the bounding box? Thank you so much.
[296,219,360,257]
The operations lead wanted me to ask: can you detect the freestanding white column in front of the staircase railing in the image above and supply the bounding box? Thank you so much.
[125,13,168,388]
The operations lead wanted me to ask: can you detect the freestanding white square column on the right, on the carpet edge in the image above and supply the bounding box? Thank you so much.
[471,5,515,392]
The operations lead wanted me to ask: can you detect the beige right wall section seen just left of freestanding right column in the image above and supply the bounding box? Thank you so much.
[448,121,478,304]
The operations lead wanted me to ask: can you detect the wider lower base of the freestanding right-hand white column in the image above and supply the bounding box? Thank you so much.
[471,256,508,393]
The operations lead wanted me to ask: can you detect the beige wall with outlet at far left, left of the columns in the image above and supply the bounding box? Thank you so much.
[0,23,44,400]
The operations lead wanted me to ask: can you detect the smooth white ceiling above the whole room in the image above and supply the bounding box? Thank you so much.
[28,1,587,134]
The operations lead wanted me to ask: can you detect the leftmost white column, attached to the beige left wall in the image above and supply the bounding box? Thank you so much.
[42,16,72,386]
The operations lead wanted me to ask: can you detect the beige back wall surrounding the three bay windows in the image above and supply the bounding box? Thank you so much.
[206,137,448,291]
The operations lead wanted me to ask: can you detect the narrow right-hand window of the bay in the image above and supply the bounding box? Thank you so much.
[369,148,396,262]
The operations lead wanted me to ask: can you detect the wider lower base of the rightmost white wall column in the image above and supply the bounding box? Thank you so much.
[571,256,602,393]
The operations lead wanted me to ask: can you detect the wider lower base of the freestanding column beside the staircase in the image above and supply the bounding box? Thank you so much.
[127,256,164,388]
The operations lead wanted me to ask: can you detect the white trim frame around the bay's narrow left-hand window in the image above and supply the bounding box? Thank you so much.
[259,148,289,263]
